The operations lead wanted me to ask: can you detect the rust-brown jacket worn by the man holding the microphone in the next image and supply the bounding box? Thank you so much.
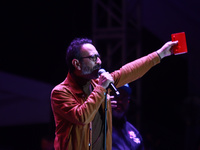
[51,52,160,150]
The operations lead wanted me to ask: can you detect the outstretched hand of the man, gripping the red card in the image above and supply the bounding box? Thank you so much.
[156,41,178,59]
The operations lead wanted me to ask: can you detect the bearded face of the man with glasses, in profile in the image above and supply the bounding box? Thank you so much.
[81,43,101,79]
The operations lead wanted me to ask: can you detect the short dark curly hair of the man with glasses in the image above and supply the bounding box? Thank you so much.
[66,38,92,72]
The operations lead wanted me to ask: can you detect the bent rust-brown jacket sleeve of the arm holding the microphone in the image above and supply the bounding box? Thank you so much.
[51,86,106,125]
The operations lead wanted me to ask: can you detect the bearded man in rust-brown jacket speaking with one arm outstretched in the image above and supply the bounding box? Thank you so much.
[51,38,177,150]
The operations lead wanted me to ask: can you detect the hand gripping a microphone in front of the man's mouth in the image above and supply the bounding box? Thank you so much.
[98,69,120,96]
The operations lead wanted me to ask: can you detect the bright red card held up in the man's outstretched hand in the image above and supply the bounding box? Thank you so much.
[171,32,187,55]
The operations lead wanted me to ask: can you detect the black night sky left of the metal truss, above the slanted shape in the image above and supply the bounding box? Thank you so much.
[0,1,92,84]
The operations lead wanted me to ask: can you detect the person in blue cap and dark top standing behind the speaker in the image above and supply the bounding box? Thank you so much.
[111,84,144,150]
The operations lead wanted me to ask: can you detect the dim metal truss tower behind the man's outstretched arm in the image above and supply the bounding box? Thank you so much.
[92,0,142,126]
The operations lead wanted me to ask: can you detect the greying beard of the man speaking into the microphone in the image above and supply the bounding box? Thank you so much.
[82,65,101,79]
